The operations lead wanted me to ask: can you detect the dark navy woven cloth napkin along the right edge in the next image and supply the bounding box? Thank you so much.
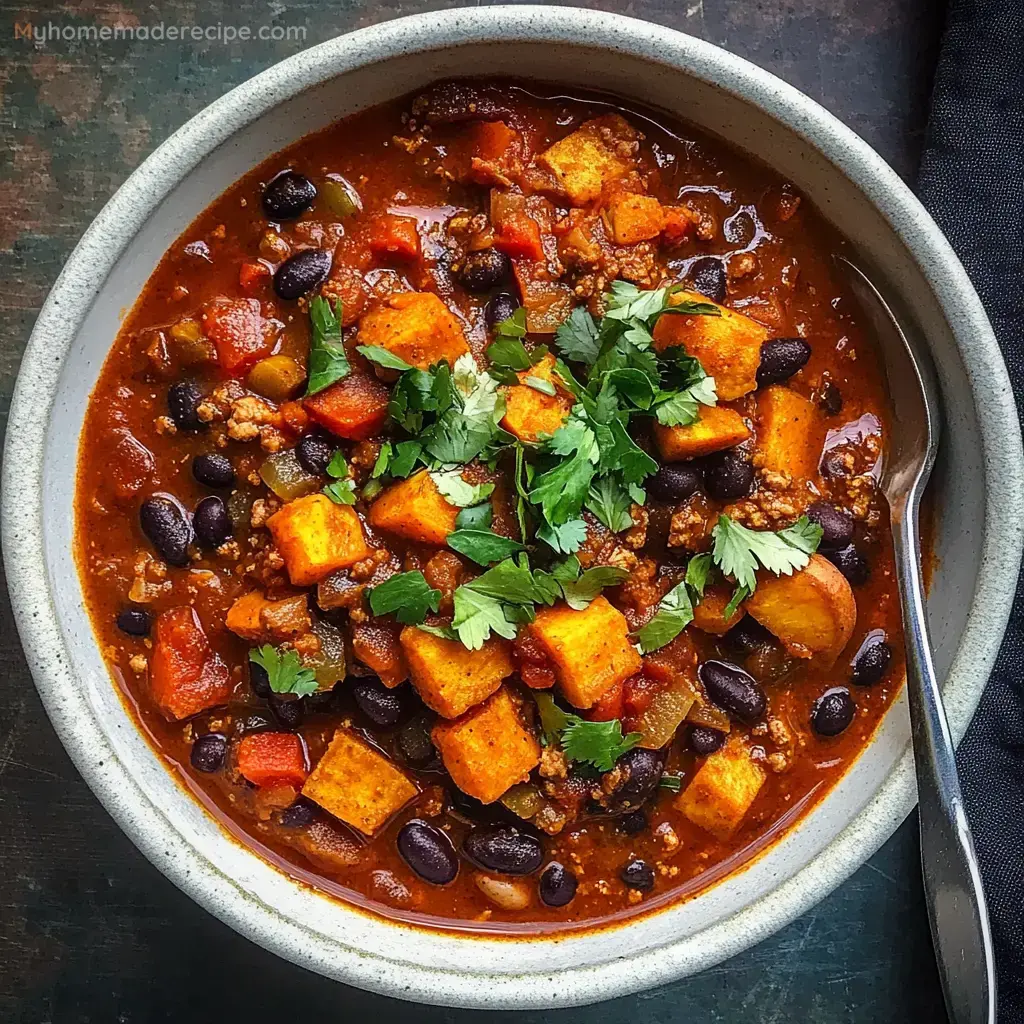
[918,0,1024,1024]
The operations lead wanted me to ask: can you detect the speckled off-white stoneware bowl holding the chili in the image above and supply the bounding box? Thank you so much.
[3,6,1022,1008]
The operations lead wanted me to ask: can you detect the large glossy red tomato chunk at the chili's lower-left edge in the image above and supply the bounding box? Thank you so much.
[150,605,231,721]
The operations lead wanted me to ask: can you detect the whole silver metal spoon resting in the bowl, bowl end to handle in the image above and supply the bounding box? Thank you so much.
[836,256,995,1024]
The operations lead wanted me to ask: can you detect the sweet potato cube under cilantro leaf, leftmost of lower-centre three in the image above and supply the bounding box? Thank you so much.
[399,626,515,718]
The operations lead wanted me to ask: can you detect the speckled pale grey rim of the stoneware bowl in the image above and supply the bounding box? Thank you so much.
[2,5,1024,1009]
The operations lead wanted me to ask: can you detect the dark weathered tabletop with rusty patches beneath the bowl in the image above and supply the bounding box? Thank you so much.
[0,0,944,1024]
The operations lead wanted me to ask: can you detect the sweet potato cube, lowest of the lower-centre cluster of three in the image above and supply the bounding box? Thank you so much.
[431,686,541,804]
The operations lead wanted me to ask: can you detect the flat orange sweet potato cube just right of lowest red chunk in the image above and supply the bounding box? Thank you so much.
[302,729,419,836]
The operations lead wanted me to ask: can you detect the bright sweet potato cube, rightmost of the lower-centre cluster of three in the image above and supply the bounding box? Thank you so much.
[529,596,641,708]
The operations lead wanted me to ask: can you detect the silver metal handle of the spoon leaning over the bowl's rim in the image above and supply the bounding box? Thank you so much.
[892,488,995,1024]
